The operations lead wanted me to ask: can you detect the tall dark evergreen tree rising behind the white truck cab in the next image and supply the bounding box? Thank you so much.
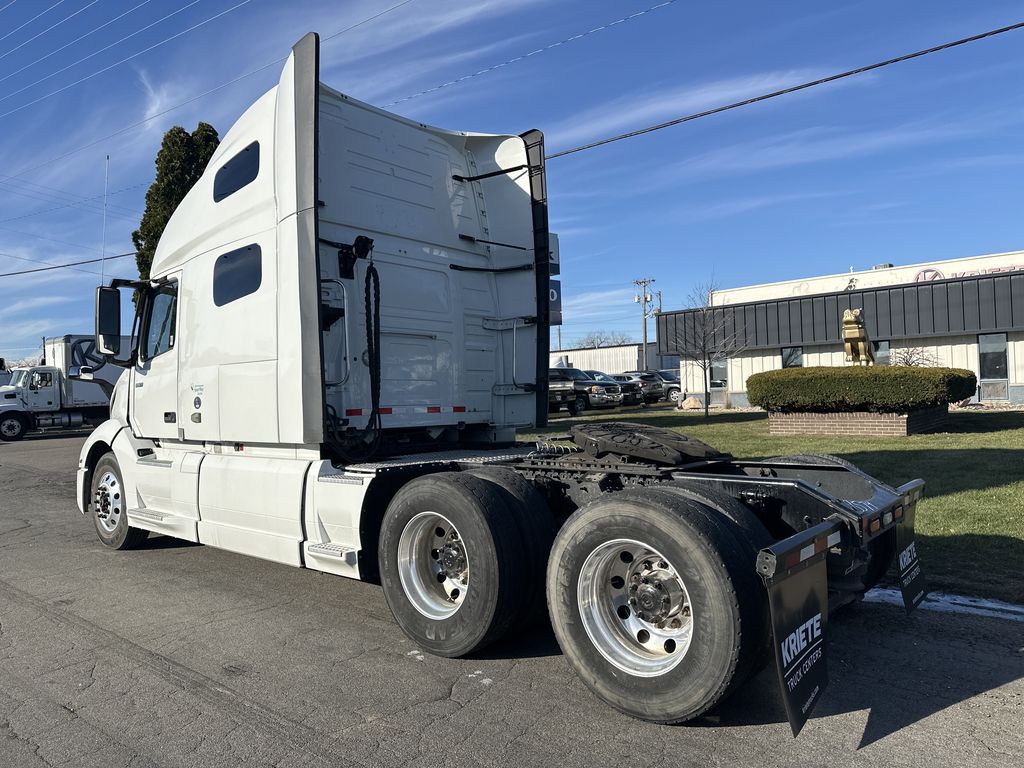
[131,123,220,280]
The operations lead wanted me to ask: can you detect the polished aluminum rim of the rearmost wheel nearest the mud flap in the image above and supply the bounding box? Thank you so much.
[577,539,694,677]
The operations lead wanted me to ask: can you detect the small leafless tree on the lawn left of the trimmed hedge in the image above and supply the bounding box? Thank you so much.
[675,280,742,418]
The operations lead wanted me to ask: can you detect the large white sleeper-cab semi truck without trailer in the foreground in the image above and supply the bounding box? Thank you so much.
[78,34,924,730]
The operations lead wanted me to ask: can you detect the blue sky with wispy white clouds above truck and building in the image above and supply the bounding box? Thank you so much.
[0,0,1024,358]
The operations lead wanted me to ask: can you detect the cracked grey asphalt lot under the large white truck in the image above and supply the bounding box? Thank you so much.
[0,434,1024,768]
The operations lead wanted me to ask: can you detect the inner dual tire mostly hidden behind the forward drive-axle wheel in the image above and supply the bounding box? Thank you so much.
[469,467,555,625]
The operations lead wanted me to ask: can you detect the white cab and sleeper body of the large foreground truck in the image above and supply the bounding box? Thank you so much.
[78,36,548,578]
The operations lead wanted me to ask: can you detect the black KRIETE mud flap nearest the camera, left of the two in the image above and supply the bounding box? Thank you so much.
[757,518,842,736]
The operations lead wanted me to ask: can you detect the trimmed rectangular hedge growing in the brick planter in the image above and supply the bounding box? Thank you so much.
[746,366,978,414]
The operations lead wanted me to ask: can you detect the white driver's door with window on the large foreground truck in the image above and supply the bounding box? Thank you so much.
[128,280,180,439]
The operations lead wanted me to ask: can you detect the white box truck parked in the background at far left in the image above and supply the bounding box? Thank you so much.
[0,335,123,442]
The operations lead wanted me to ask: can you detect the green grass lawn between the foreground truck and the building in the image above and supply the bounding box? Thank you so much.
[520,409,1024,603]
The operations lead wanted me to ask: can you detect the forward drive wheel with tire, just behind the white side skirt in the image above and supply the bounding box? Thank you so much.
[378,472,526,657]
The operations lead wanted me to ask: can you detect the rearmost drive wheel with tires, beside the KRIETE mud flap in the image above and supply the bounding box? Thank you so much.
[548,488,768,723]
